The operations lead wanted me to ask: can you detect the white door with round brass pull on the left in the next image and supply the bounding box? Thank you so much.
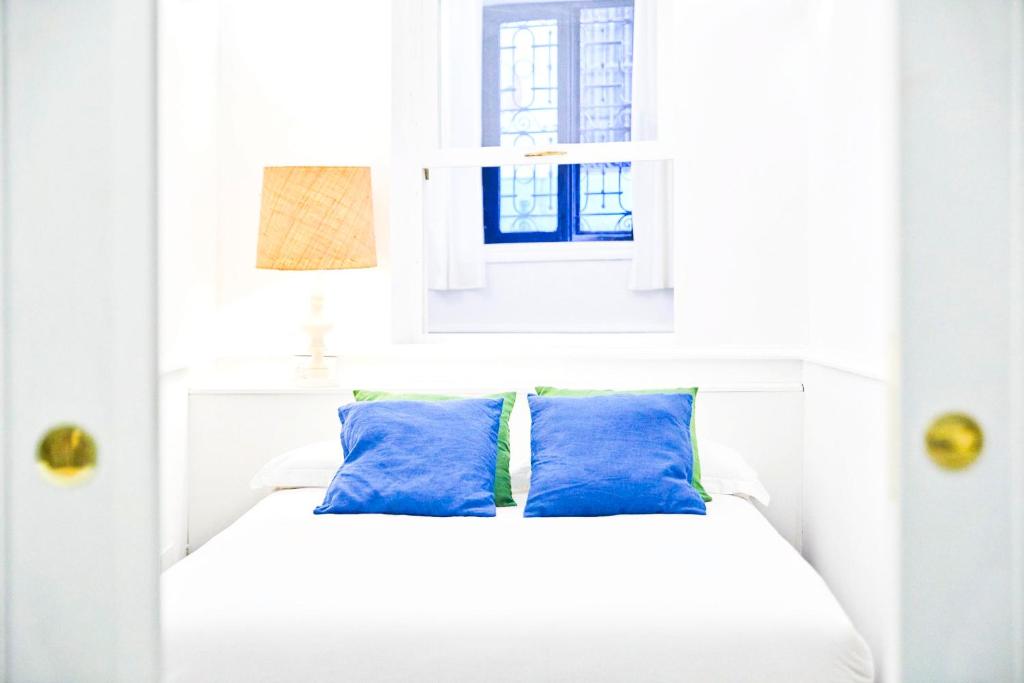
[0,0,159,683]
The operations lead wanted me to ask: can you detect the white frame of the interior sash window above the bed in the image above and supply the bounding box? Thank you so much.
[388,0,686,348]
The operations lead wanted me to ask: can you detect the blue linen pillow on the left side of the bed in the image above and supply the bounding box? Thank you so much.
[313,398,504,517]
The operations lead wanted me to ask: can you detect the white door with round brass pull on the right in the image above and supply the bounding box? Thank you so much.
[899,0,1024,683]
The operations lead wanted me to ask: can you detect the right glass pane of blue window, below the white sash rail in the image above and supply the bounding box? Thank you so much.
[580,162,633,234]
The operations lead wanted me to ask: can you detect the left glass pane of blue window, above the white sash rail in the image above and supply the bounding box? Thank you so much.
[498,19,558,148]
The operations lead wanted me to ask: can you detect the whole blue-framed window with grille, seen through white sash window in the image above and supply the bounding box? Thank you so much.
[482,0,633,244]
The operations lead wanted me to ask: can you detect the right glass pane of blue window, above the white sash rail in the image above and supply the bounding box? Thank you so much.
[580,5,633,142]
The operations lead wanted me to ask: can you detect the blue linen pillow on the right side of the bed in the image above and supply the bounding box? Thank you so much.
[523,394,706,517]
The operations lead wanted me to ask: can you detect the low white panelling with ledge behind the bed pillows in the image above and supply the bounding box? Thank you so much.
[187,352,804,550]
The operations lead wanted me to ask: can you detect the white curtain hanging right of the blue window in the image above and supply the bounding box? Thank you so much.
[630,0,675,290]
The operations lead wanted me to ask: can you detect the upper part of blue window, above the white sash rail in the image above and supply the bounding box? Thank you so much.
[481,0,633,146]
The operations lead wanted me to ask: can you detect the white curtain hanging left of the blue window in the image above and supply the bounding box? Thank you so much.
[423,0,486,290]
